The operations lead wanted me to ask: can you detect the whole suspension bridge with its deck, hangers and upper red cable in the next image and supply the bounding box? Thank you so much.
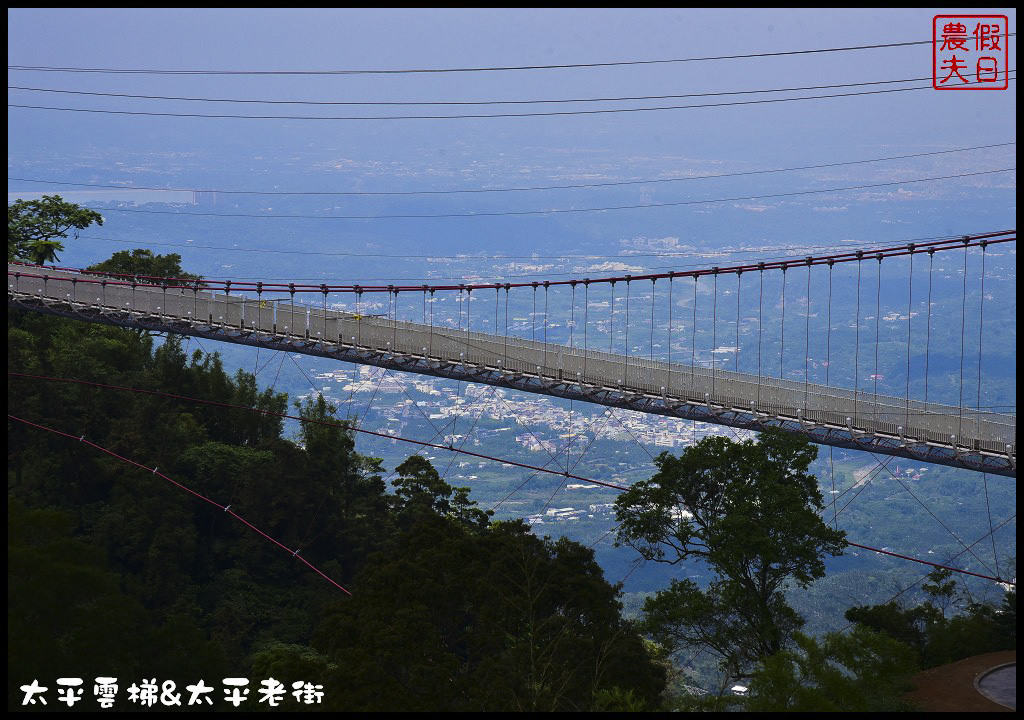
[7,230,1016,477]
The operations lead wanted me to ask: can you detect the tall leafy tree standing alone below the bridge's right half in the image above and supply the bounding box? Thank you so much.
[615,430,845,678]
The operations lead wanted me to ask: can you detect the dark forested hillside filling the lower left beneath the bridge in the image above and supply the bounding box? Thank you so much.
[8,311,666,711]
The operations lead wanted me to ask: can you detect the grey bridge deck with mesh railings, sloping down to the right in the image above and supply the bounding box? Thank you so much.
[8,265,1016,475]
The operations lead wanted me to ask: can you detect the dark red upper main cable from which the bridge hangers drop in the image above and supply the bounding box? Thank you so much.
[7,229,1017,294]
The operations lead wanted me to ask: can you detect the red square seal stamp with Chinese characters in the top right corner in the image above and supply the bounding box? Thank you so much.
[932,15,1010,90]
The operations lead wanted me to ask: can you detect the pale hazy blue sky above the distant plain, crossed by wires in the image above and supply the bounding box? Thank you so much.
[7,9,1016,154]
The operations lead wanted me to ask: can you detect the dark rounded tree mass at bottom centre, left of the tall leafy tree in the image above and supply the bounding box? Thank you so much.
[313,516,665,712]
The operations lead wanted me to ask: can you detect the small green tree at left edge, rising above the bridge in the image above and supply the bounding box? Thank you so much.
[7,195,103,264]
